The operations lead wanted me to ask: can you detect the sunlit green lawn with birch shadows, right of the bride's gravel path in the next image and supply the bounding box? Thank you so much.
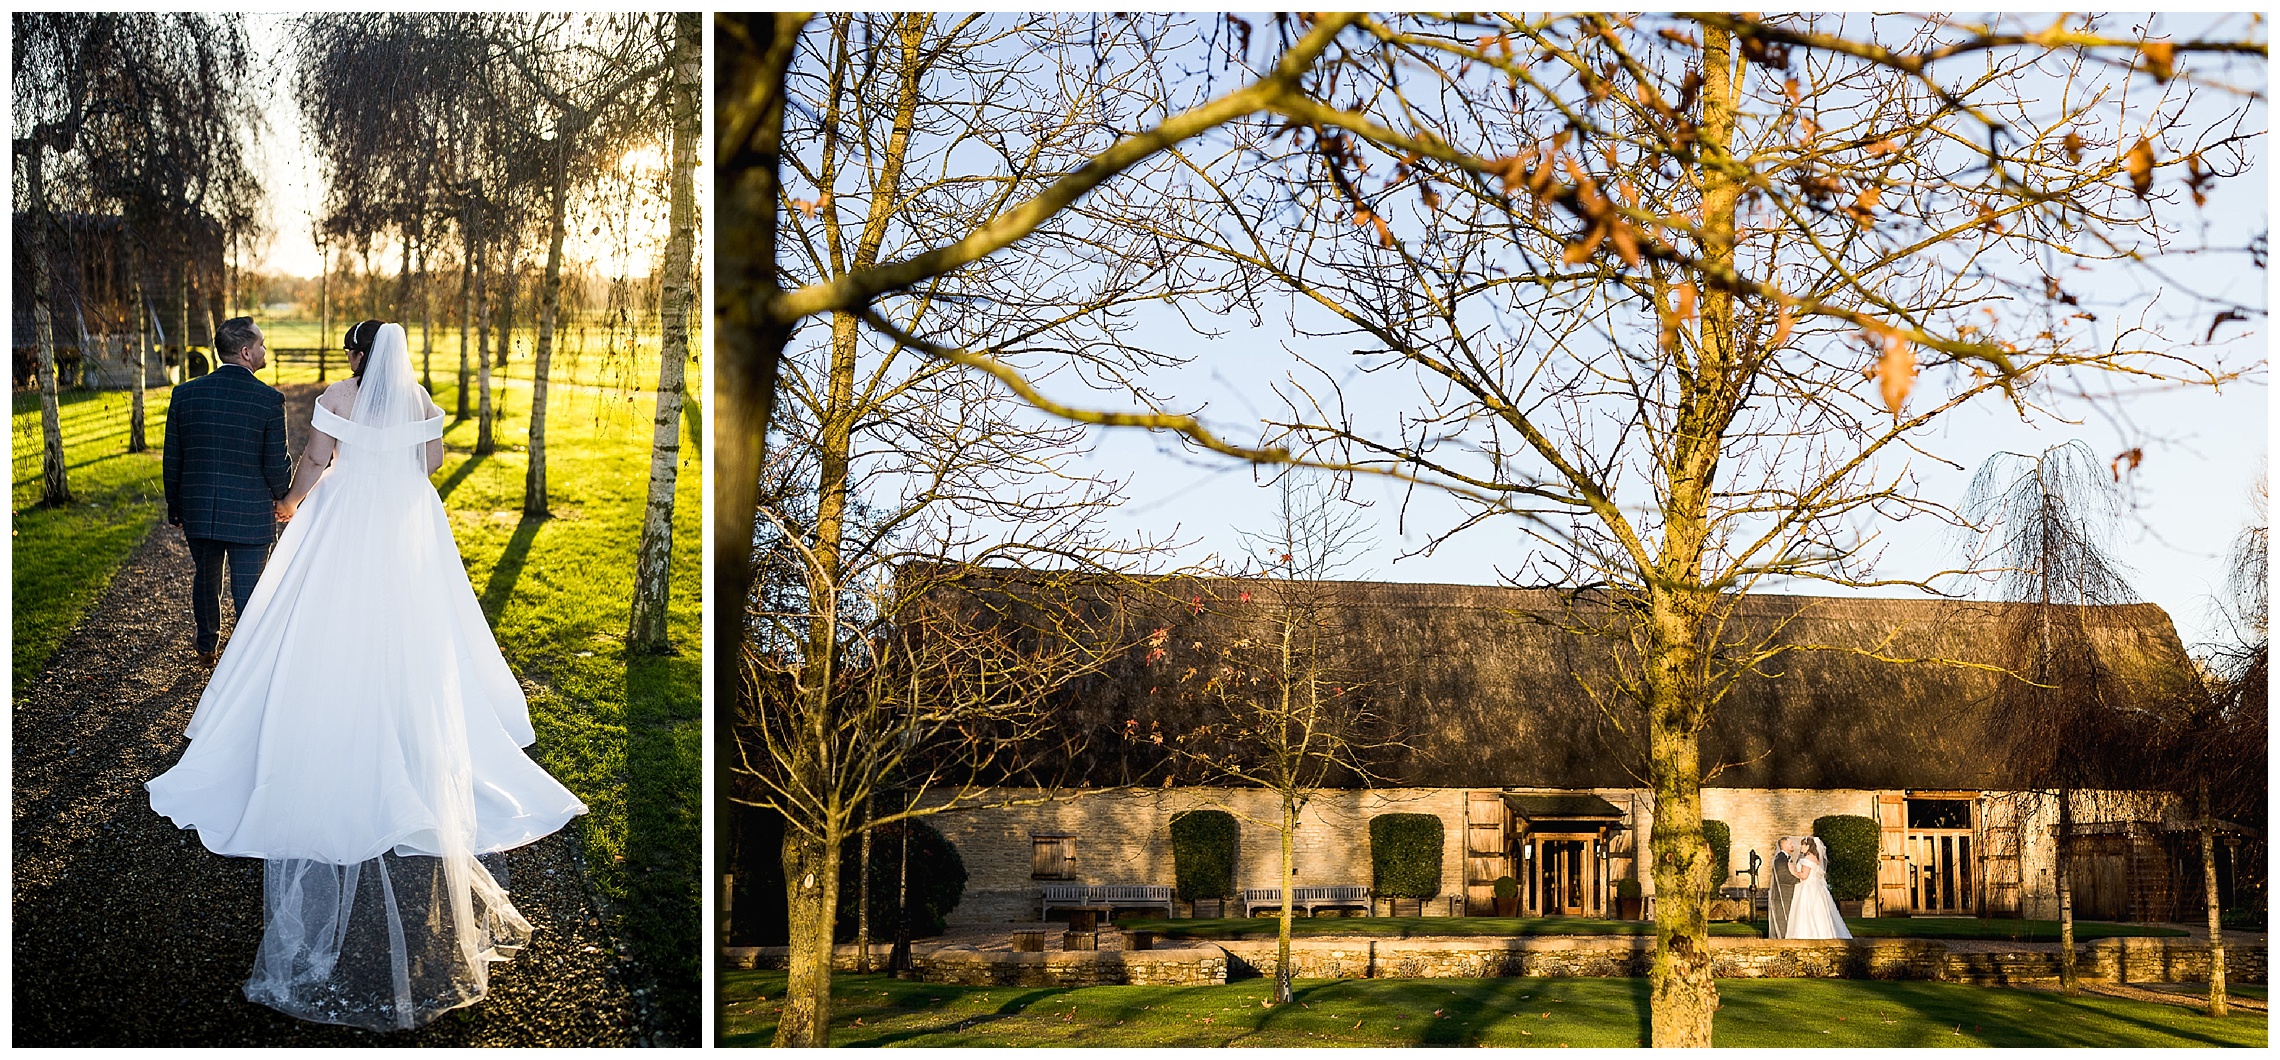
[415,335,705,1035]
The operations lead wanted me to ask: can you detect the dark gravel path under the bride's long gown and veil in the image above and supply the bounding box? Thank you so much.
[11,385,656,1046]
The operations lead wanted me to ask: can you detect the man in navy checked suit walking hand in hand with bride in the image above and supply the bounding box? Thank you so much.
[166,317,292,666]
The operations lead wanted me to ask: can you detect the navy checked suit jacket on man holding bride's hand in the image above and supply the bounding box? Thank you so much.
[164,365,292,545]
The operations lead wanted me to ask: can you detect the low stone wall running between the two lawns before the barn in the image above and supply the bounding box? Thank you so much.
[723,935,2266,987]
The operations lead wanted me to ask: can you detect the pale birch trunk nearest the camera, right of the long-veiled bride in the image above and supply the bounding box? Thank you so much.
[625,11,702,654]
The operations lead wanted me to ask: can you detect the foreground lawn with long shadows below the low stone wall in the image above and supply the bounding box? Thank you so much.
[720,971,2266,1049]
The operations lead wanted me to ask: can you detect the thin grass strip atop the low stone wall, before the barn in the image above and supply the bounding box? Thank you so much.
[1135,916,2187,941]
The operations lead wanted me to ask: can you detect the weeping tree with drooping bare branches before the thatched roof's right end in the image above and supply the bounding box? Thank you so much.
[1961,442,2166,994]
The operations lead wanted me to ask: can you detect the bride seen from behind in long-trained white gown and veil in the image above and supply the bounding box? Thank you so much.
[148,321,586,1030]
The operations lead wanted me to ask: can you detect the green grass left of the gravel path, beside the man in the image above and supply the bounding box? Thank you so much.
[9,388,172,688]
